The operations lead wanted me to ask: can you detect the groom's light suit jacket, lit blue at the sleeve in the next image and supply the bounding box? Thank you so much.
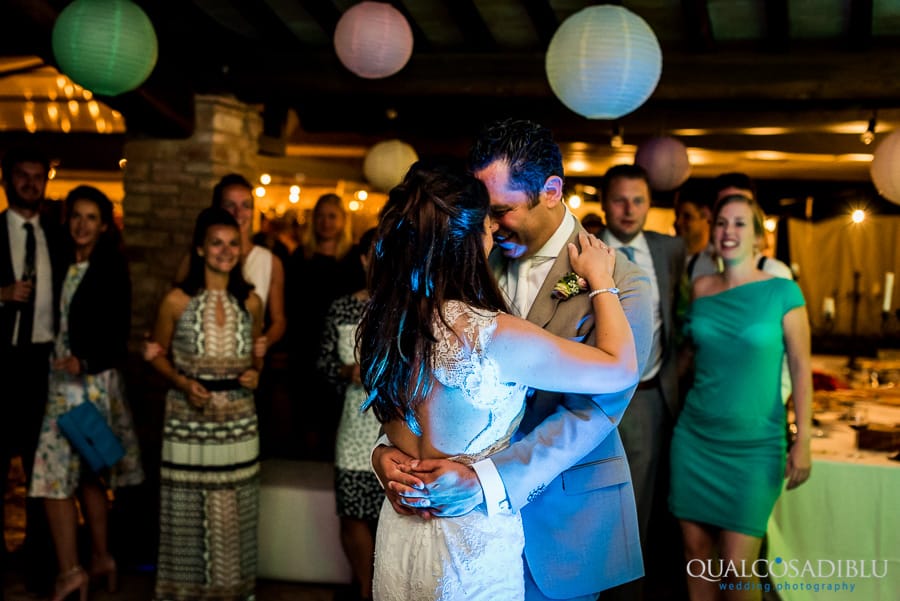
[491,227,653,599]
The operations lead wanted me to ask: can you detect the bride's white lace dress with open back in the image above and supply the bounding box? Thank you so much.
[374,301,526,601]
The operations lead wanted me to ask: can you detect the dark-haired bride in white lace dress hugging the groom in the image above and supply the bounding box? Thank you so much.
[358,162,638,601]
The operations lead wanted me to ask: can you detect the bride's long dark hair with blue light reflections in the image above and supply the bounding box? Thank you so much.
[357,161,508,434]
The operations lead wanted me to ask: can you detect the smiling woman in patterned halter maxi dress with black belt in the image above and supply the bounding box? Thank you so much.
[152,207,262,601]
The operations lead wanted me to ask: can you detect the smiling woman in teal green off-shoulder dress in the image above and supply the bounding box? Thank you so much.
[669,195,812,600]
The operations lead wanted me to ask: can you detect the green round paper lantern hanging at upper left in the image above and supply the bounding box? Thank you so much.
[53,0,158,96]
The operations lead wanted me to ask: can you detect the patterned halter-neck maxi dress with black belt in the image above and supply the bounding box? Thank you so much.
[156,290,259,601]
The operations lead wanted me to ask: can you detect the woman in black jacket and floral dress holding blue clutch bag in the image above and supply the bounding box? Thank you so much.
[28,186,144,601]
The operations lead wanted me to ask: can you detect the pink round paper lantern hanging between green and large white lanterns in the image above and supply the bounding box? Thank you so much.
[334,2,413,79]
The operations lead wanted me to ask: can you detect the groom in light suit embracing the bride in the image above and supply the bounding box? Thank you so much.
[373,120,653,601]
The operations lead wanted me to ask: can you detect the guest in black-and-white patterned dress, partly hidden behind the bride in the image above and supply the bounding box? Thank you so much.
[318,228,384,599]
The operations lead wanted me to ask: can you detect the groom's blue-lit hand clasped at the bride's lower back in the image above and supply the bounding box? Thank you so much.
[391,459,484,517]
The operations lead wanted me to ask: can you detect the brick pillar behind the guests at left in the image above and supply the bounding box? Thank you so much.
[123,96,262,338]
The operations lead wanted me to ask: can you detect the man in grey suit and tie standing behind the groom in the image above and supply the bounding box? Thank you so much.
[601,165,685,600]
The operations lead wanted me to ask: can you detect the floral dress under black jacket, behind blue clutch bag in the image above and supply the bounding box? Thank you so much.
[28,261,144,499]
